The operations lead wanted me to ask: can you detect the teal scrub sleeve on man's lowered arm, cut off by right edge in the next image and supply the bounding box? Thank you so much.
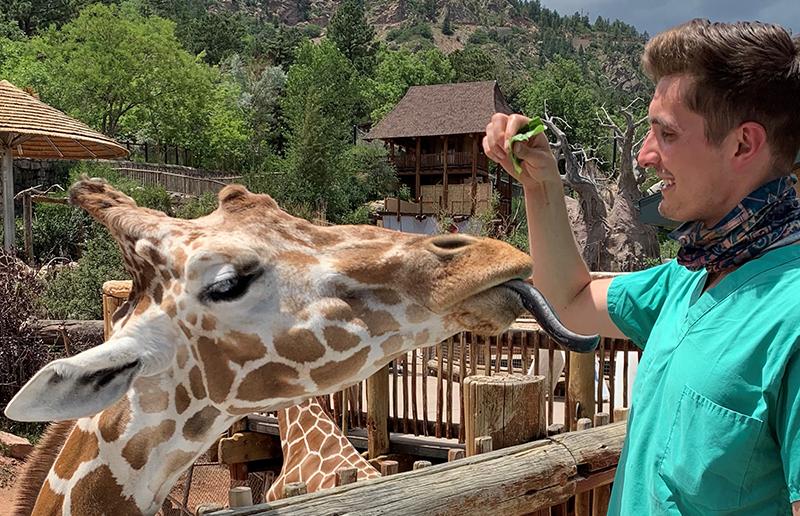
[774,341,800,502]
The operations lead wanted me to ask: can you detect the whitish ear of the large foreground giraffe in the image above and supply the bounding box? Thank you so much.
[5,338,147,421]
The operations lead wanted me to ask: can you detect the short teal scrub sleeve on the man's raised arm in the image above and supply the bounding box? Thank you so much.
[607,261,676,349]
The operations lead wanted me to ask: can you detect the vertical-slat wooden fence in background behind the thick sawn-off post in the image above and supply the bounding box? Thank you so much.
[322,320,641,443]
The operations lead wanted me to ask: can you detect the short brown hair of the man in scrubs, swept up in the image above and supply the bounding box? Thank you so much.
[642,19,800,169]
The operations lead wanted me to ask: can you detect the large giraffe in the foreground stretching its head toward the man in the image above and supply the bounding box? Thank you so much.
[5,179,584,516]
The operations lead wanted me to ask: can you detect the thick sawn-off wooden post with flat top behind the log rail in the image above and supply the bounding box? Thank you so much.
[464,372,547,457]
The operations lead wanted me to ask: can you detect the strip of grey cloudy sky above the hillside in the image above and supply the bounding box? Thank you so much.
[542,0,800,36]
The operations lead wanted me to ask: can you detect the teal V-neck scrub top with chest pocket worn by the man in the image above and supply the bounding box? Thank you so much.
[608,245,800,516]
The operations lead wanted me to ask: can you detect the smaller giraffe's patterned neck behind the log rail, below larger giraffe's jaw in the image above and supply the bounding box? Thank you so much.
[265,398,381,502]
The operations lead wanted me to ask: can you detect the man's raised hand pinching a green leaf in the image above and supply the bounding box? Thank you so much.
[483,113,561,188]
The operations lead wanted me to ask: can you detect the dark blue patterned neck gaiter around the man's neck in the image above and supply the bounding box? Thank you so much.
[669,175,800,272]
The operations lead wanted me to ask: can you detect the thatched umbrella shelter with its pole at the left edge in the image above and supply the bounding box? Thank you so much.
[0,77,128,251]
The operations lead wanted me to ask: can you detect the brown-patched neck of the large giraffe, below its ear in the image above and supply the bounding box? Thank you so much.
[33,378,238,516]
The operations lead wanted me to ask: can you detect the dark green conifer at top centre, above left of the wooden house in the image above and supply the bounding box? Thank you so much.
[328,0,376,75]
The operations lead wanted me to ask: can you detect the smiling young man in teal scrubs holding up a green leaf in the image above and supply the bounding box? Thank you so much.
[483,20,800,515]
